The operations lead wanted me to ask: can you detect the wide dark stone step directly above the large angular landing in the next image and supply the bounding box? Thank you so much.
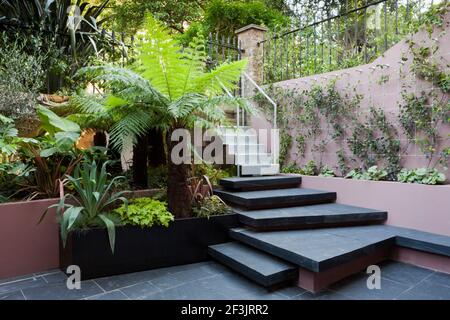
[233,203,387,230]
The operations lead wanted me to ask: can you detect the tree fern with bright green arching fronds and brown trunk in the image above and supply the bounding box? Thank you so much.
[73,17,249,217]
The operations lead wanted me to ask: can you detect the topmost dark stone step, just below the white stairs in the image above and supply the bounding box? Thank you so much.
[219,175,302,191]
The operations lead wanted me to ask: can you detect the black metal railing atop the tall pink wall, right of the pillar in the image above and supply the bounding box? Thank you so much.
[259,0,448,83]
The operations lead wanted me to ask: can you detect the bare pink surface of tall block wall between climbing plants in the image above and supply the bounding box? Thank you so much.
[252,13,450,178]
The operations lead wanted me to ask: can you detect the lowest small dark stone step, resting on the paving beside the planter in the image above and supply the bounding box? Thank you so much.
[208,242,298,287]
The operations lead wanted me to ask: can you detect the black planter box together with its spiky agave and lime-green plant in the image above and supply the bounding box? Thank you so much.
[42,162,238,279]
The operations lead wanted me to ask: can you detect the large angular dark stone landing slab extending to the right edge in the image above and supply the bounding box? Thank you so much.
[230,225,450,272]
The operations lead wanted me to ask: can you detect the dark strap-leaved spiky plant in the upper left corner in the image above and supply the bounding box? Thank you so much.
[0,0,110,92]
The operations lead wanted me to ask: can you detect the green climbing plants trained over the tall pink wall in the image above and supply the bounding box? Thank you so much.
[255,3,450,184]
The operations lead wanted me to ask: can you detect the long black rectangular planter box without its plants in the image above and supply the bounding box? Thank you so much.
[60,214,243,280]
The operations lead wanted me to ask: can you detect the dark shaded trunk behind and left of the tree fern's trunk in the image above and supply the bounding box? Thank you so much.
[133,135,148,189]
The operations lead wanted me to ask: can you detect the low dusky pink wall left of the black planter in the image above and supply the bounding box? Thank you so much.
[0,199,59,279]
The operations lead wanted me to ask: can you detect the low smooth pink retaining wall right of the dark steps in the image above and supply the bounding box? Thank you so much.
[302,176,450,236]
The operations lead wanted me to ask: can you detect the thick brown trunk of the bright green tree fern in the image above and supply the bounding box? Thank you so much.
[167,131,191,218]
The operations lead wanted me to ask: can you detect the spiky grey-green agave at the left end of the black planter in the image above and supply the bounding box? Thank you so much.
[39,161,128,252]
